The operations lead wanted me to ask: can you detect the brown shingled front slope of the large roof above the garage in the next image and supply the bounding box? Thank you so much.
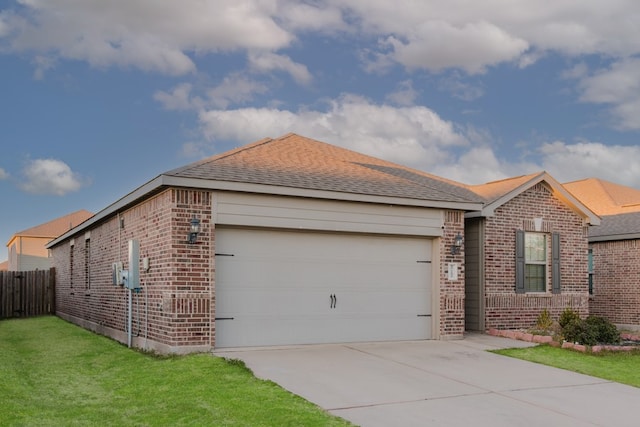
[163,133,479,203]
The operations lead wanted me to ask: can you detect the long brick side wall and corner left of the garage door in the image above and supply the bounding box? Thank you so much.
[52,189,214,352]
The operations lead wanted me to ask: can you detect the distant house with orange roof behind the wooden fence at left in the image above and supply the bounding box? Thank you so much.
[7,210,93,271]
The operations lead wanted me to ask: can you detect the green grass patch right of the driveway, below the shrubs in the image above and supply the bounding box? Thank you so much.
[494,345,640,387]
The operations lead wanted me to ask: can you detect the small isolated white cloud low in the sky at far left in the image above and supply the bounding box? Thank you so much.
[20,159,87,196]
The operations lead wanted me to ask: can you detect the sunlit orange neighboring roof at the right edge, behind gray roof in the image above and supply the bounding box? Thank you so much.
[564,178,640,215]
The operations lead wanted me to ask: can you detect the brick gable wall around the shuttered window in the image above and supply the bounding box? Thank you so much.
[484,183,589,329]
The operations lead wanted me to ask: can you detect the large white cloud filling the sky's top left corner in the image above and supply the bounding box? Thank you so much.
[0,0,294,75]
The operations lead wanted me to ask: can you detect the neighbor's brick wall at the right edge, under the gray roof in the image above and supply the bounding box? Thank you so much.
[589,240,640,326]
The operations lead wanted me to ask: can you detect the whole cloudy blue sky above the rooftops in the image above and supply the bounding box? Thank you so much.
[0,0,640,261]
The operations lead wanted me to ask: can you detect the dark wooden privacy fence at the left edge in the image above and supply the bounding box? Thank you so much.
[0,268,56,319]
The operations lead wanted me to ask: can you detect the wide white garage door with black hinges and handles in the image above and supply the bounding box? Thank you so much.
[215,228,431,348]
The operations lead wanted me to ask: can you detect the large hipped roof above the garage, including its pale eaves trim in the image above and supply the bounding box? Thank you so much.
[47,133,482,248]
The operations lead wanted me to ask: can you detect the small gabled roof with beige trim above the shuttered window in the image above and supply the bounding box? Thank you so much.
[467,171,600,225]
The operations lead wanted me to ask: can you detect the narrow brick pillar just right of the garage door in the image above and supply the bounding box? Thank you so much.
[439,211,464,339]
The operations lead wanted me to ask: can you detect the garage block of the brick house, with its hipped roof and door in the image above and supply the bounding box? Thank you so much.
[48,134,482,353]
